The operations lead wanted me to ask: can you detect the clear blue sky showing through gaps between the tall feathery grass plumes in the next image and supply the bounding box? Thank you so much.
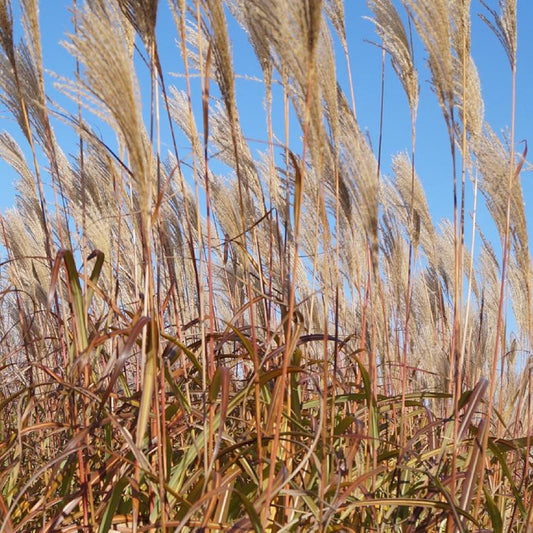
[0,0,533,254]
